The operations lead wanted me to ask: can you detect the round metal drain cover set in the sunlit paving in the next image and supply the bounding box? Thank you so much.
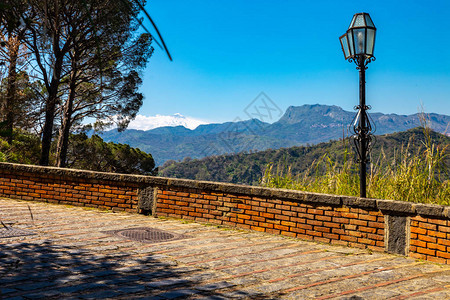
[105,227,186,243]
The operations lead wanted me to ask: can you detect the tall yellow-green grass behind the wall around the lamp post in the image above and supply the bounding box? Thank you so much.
[262,129,450,205]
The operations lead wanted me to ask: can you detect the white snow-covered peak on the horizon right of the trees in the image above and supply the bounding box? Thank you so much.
[128,113,208,130]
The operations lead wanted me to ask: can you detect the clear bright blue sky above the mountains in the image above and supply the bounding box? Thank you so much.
[140,0,450,122]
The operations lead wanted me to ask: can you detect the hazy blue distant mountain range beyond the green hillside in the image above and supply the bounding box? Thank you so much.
[101,104,450,165]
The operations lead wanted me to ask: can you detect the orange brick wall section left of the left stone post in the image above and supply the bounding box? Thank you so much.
[0,166,142,212]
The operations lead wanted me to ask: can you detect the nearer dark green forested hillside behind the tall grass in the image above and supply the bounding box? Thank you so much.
[160,128,450,185]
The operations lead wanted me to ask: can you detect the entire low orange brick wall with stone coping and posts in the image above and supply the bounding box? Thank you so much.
[0,163,450,264]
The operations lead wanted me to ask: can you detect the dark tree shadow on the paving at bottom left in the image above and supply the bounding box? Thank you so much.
[0,241,267,299]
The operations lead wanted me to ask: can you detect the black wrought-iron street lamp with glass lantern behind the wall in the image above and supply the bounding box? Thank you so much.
[339,13,377,198]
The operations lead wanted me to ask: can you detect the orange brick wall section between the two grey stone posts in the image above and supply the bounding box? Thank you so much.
[156,188,384,251]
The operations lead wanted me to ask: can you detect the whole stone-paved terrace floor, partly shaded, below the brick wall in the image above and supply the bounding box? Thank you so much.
[0,199,450,299]
